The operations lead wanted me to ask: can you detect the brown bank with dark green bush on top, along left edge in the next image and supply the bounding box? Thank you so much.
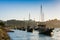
[0,22,10,40]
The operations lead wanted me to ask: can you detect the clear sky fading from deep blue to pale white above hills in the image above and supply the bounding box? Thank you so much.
[0,0,60,21]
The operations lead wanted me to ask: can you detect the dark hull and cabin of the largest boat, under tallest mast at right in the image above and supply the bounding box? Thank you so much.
[38,25,54,36]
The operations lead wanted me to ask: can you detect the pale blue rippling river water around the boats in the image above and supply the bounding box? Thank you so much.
[8,29,60,40]
